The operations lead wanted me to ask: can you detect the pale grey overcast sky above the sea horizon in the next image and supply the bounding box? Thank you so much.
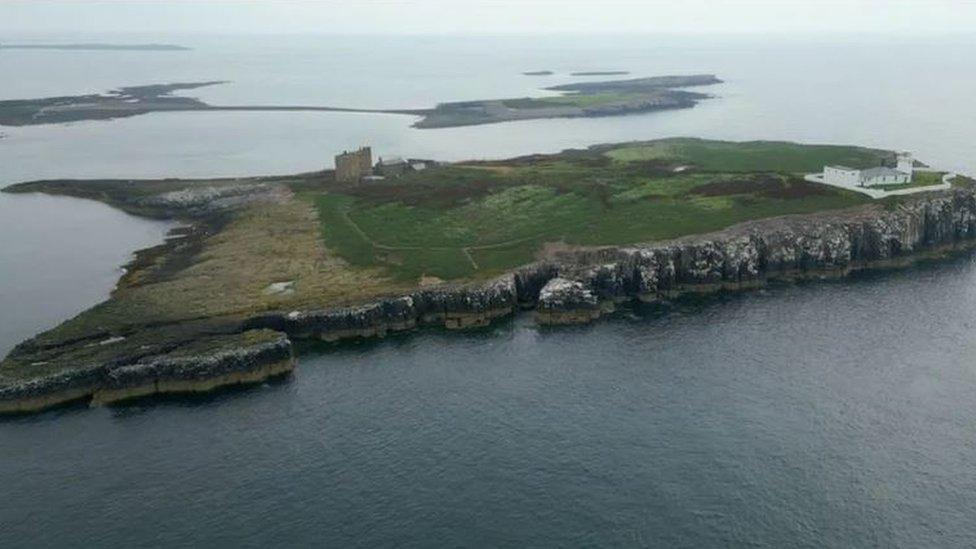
[0,0,976,35]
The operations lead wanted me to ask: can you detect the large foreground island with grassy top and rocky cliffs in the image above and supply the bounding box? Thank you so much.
[0,138,976,413]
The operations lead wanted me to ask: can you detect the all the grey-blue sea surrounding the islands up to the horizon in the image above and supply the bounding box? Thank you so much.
[0,34,976,548]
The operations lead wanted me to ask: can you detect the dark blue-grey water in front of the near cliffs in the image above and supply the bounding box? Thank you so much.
[0,257,976,547]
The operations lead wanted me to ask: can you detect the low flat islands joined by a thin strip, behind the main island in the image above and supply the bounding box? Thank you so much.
[0,75,721,128]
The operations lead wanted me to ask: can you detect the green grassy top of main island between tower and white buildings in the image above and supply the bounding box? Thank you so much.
[301,139,890,281]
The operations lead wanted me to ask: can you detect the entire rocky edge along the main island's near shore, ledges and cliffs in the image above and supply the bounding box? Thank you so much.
[0,187,976,413]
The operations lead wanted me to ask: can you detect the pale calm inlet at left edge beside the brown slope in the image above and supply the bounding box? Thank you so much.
[0,193,177,358]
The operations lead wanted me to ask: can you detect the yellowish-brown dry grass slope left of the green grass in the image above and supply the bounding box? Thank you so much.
[22,200,412,344]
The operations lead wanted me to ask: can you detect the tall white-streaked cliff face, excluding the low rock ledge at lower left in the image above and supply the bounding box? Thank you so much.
[246,189,976,341]
